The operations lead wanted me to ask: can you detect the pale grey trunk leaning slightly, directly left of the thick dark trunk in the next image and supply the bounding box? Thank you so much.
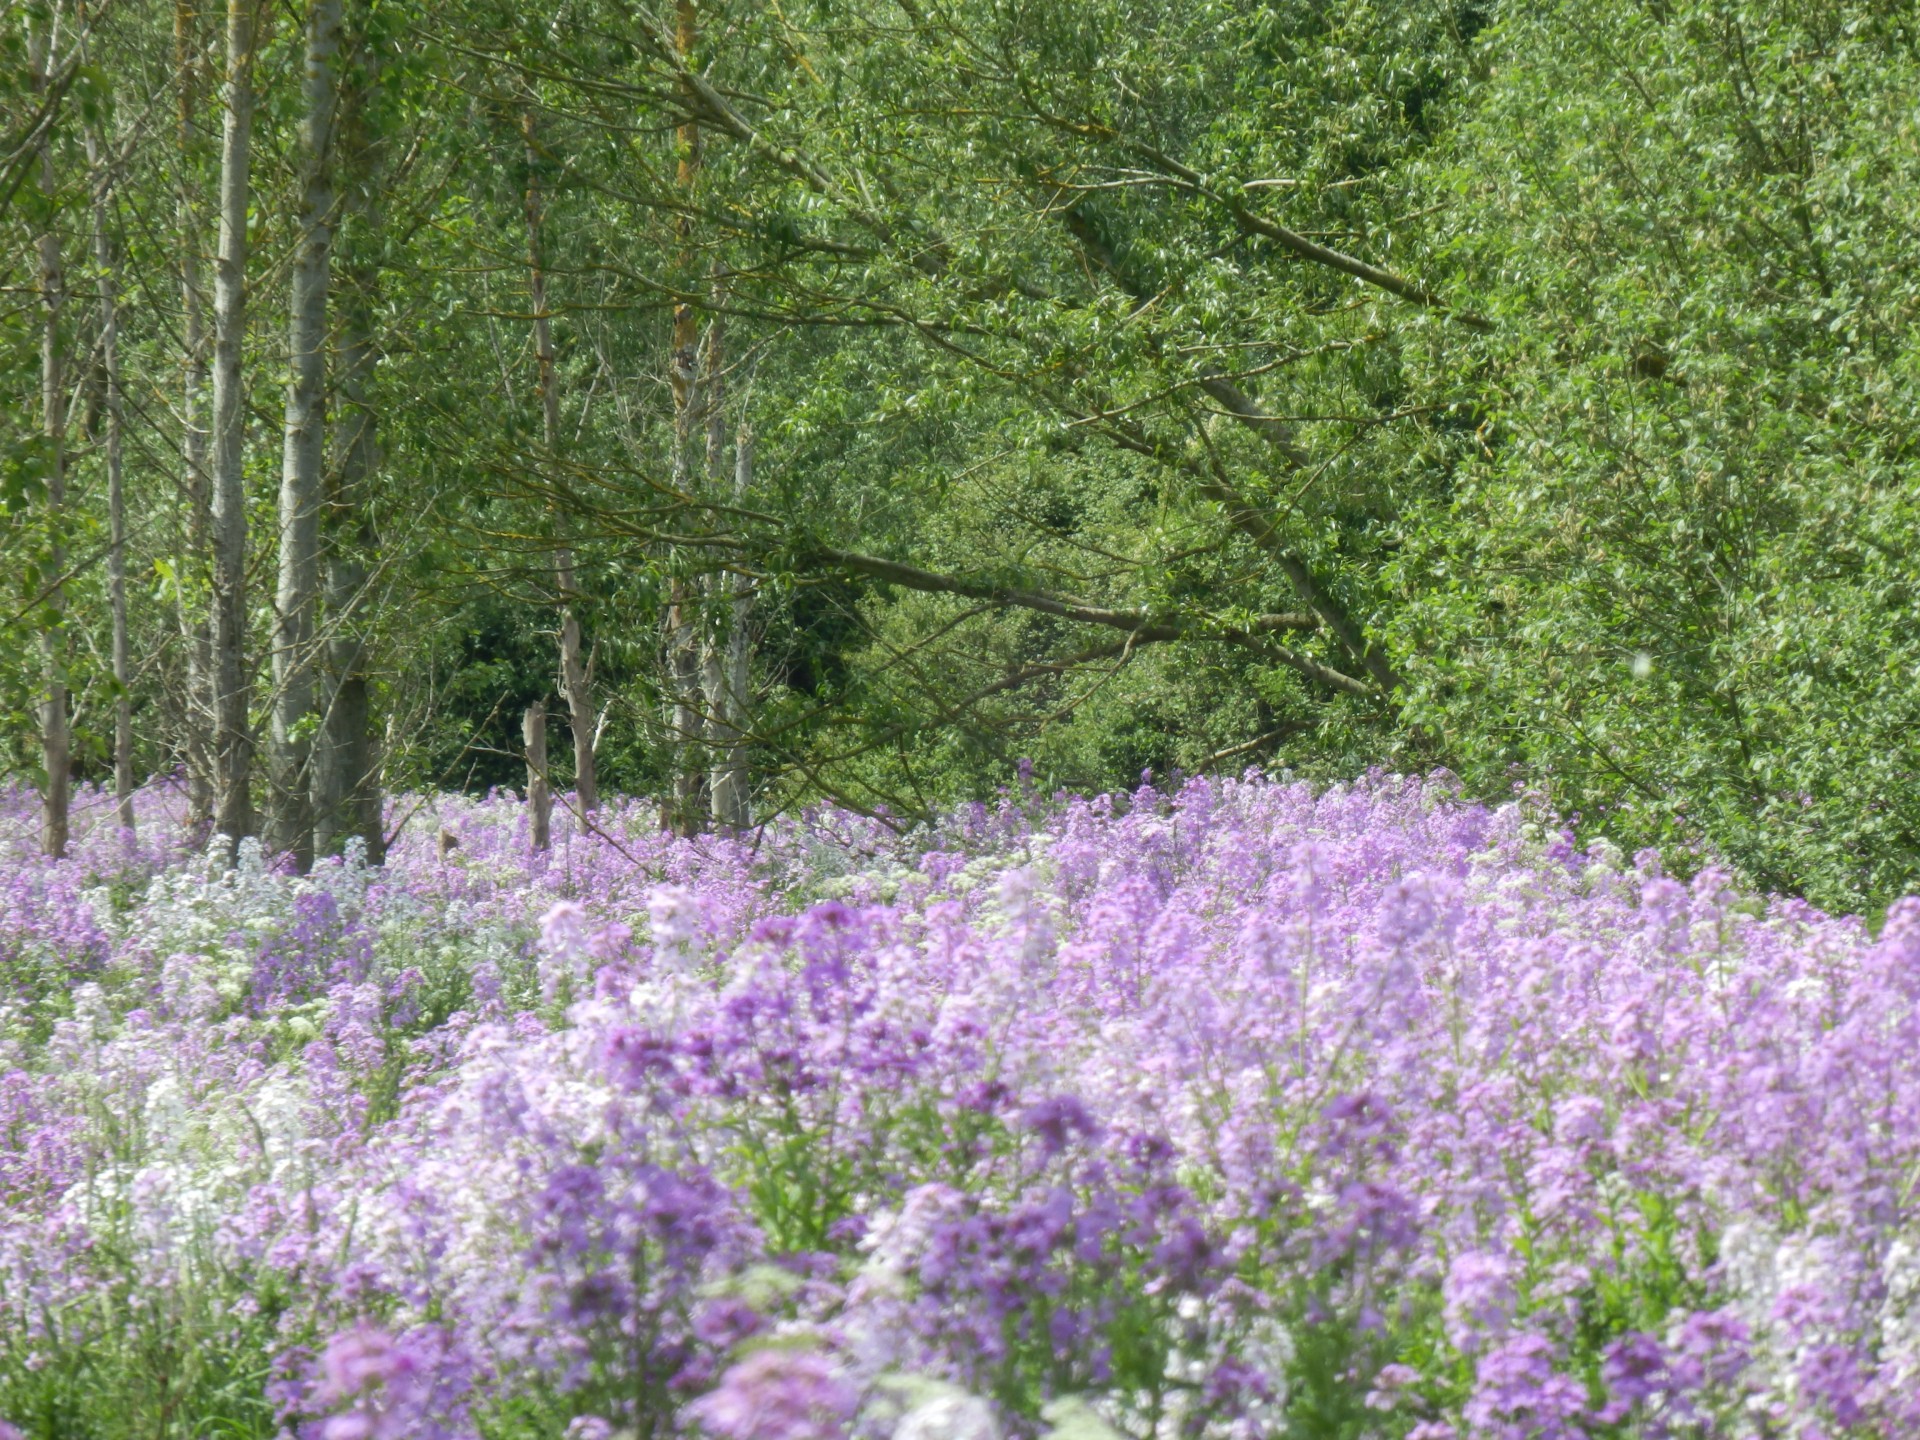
[267,0,342,872]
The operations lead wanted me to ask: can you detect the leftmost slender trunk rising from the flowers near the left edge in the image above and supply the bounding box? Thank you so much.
[27,12,73,858]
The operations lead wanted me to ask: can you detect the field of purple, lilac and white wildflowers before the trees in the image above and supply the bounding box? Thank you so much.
[0,776,1920,1440]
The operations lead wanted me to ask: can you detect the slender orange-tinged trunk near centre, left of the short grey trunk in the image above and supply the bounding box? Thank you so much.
[666,0,707,835]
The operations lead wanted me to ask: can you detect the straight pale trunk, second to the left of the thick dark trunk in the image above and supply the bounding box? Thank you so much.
[213,0,255,843]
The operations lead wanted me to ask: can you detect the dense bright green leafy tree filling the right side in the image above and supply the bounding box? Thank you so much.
[1396,4,1920,906]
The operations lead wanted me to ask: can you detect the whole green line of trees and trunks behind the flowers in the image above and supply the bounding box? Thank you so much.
[0,0,1920,906]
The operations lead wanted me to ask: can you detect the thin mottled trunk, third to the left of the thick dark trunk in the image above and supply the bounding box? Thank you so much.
[173,0,215,835]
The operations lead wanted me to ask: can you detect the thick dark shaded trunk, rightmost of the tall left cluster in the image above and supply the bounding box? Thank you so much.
[313,36,386,864]
